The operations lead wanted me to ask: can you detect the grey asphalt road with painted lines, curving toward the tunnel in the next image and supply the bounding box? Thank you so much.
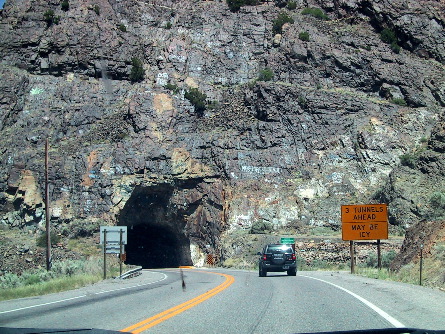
[0,269,445,333]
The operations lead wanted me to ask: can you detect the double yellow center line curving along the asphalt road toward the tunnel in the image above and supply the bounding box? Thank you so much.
[120,271,235,334]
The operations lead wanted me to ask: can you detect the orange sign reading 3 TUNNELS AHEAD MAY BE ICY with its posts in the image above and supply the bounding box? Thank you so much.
[341,204,388,273]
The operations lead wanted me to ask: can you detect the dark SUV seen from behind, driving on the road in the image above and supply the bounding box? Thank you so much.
[258,244,297,277]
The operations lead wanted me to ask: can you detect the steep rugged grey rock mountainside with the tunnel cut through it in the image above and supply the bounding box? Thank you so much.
[0,0,445,265]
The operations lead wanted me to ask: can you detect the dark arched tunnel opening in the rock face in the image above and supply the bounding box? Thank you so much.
[118,184,192,268]
